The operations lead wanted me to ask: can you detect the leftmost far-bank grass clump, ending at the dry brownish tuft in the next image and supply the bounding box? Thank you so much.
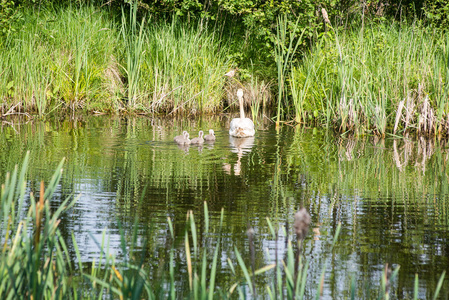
[0,5,118,116]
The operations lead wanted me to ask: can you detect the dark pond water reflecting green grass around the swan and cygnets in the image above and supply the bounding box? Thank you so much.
[0,116,449,299]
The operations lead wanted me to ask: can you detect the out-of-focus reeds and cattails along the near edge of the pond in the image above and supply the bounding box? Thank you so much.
[0,152,445,299]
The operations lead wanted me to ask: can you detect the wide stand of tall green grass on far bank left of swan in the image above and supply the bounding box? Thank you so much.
[0,6,234,116]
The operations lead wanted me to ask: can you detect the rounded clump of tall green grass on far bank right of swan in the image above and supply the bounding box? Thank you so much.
[290,23,449,136]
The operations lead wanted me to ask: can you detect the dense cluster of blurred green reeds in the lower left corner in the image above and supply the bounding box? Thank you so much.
[0,153,75,299]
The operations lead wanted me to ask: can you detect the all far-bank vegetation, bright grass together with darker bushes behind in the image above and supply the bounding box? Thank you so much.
[0,0,449,137]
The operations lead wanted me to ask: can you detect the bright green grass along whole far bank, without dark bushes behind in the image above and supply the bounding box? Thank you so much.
[0,6,449,136]
